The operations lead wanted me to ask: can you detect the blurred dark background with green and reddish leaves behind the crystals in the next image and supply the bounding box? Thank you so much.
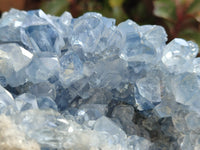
[0,0,200,49]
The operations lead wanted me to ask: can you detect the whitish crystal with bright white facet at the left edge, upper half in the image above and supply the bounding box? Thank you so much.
[0,43,33,86]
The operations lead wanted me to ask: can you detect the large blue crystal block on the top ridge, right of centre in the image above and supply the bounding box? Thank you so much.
[118,20,167,61]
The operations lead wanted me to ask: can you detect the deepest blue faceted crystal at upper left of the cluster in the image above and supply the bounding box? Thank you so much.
[22,25,64,55]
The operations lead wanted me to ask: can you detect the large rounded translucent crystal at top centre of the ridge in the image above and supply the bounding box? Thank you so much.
[71,13,104,52]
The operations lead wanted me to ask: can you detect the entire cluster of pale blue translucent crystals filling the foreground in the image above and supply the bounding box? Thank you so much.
[0,9,200,150]
